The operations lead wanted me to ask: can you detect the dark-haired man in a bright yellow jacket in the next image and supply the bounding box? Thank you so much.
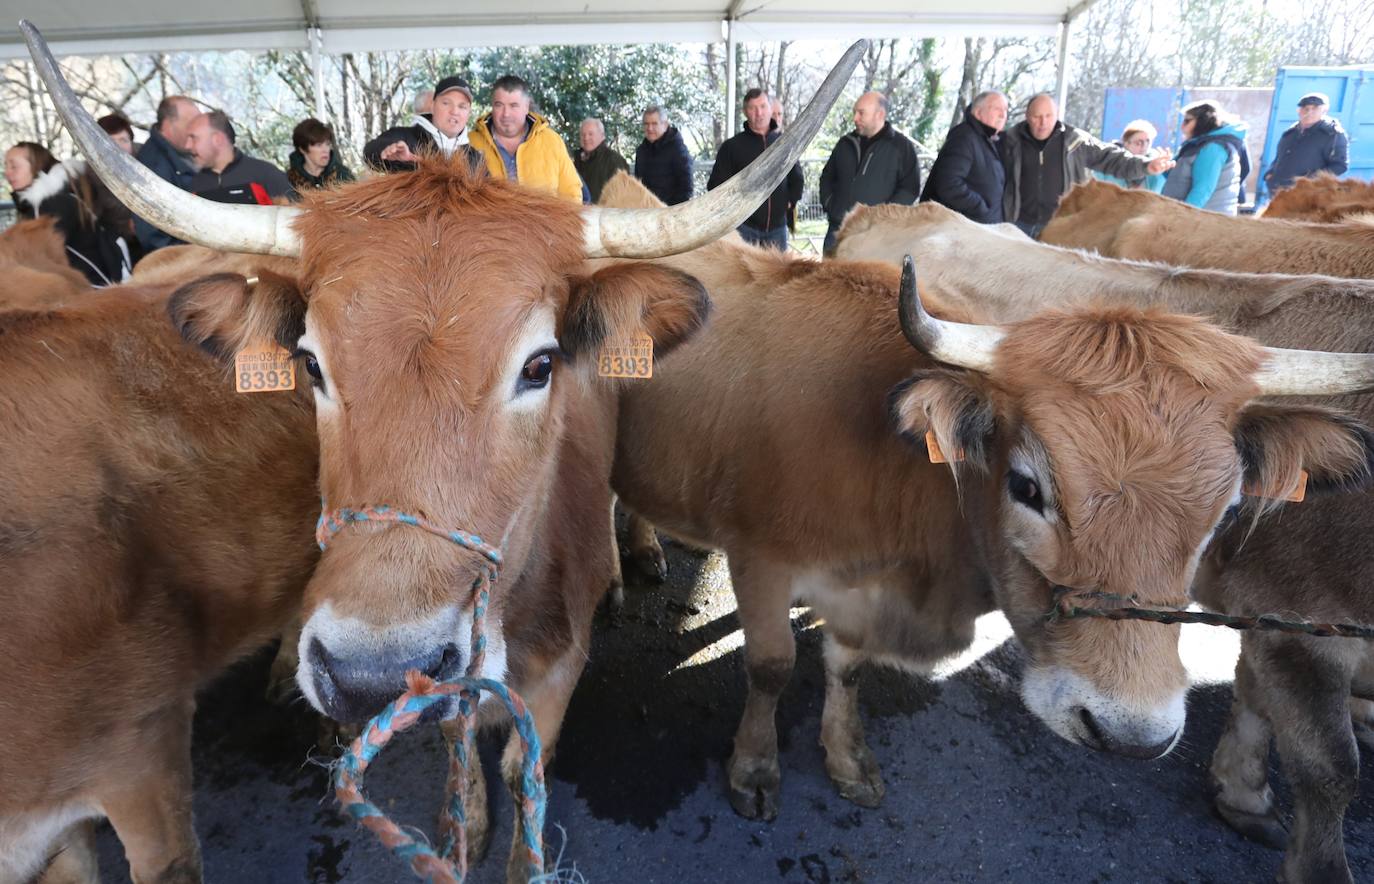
[469,74,583,202]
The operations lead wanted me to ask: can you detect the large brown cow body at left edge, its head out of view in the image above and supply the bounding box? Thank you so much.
[0,285,317,881]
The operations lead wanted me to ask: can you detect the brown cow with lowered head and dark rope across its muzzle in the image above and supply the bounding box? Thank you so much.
[603,176,1370,818]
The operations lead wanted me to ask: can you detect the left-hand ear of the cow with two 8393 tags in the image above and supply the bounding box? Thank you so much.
[168,271,305,360]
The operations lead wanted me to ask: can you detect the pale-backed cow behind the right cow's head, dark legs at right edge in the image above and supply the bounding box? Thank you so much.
[837,203,1374,881]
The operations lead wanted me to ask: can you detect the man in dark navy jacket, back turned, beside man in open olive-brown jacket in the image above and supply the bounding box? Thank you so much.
[921,92,1009,224]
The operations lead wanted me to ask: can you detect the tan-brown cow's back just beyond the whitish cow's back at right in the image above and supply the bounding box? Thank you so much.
[1040,181,1374,279]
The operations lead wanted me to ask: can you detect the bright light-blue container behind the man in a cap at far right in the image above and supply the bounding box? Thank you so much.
[1259,65,1374,202]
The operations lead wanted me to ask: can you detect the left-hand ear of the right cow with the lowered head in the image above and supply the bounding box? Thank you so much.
[890,368,998,473]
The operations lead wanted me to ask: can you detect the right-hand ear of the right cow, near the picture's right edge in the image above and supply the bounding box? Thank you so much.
[1235,404,1374,499]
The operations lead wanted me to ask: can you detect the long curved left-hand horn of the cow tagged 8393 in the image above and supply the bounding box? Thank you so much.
[19,21,301,257]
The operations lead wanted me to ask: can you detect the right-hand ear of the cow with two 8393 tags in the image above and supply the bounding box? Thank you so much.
[559,264,710,362]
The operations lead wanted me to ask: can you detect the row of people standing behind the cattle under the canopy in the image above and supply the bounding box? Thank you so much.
[4,74,1348,285]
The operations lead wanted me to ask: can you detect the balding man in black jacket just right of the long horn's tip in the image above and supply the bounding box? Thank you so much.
[820,92,921,256]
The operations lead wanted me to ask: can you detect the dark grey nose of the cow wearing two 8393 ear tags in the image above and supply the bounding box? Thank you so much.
[306,638,463,723]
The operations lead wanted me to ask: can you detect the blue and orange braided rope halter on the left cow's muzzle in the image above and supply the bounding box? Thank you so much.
[315,506,548,884]
